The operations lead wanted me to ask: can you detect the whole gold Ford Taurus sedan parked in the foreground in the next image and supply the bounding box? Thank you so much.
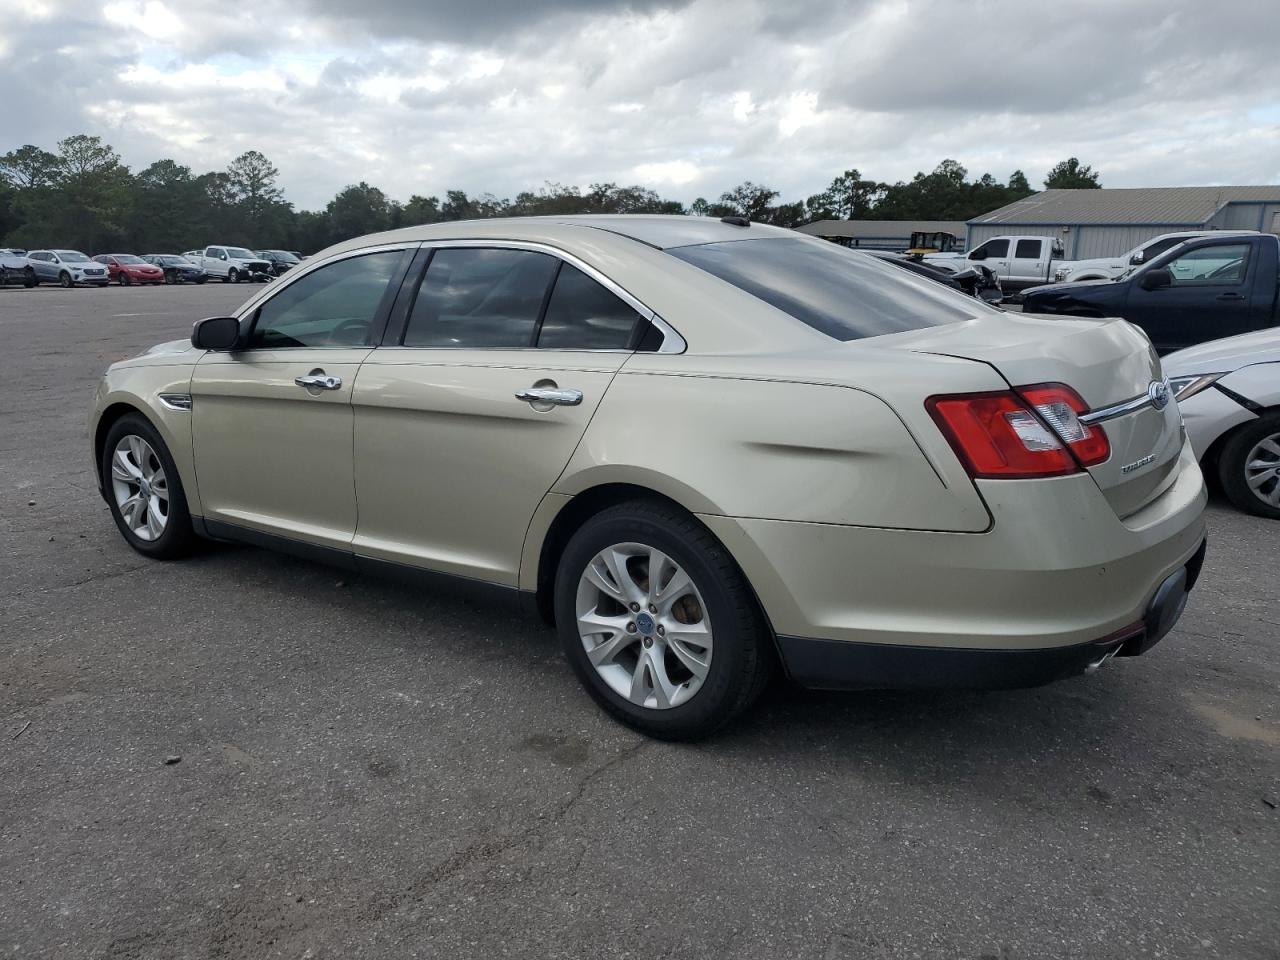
[91,216,1204,739]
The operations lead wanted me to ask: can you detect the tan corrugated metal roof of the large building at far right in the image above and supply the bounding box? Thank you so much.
[969,186,1280,225]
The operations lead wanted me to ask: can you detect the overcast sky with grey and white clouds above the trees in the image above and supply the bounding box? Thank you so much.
[0,0,1280,207]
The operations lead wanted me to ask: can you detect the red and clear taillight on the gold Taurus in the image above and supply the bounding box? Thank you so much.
[925,384,1111,480]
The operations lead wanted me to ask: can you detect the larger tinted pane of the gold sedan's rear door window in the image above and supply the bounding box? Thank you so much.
[404,247,559,349]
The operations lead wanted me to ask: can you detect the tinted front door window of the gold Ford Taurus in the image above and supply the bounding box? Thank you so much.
[248,250,403,349]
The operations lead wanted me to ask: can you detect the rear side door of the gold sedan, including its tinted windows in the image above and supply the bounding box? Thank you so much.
[355,243,648,586]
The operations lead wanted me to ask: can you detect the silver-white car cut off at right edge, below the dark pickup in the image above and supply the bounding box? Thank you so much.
[1164,329,1280,520]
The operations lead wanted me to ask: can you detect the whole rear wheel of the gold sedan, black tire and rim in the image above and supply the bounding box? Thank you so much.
[556,500,774,740]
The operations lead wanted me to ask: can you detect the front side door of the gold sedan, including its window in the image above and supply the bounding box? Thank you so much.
[191,243,417,552]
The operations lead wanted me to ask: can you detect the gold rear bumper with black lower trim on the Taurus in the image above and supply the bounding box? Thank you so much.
[701,444,1206,686]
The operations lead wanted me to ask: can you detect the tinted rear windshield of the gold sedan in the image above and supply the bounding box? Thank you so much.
[667,237,996,340]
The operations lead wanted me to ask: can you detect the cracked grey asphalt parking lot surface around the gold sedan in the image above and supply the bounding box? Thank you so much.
[0,283,1280,960]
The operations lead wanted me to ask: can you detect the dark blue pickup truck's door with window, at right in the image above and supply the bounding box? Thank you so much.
[1123,241,1257,353]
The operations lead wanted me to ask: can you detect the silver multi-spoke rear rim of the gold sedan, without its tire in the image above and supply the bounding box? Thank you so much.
[576,543,713,710]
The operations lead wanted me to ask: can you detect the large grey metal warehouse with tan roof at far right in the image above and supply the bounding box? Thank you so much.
[968,186,1280,260]
